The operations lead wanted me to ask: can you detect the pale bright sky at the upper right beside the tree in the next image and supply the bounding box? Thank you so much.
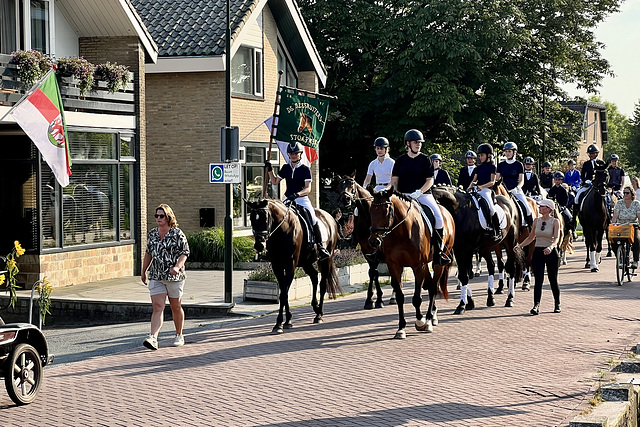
[564,0,640,118]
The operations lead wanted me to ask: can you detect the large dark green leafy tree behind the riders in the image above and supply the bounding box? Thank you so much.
[298,0,621,181]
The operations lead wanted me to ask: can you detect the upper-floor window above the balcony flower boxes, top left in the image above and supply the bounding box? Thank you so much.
[0,0,52,54]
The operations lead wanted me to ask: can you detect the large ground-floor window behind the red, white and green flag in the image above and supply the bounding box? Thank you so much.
[41,131,135,249]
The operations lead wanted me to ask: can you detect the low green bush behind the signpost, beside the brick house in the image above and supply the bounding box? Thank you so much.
[187,228,255,263]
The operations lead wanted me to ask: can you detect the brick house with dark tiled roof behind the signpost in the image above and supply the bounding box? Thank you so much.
[133,0,326,235]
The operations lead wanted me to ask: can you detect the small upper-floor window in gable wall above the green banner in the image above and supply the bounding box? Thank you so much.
[231,46,263,96]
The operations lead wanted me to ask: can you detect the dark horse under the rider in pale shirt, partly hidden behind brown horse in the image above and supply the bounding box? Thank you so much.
[338,172,384,310]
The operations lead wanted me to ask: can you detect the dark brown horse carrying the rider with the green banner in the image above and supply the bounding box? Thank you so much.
[247,199,342,333]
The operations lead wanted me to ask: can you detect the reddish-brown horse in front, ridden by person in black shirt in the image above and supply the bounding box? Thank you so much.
[369,190,455,339]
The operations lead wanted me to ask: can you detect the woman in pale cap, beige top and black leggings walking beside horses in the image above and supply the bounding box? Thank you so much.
[516,199,561,316]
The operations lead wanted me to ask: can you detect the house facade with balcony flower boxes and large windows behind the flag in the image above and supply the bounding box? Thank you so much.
[0,0,157,287]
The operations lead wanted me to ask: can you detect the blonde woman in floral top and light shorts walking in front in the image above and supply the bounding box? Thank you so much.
[142,204,189,350]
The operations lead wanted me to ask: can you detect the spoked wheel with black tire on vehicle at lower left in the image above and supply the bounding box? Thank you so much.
[4,344,42,405]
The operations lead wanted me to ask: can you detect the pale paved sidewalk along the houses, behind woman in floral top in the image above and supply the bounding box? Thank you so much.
[3,270,370,325]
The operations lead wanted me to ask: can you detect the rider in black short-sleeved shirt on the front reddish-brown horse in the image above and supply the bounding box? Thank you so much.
[391,129,451,266]
